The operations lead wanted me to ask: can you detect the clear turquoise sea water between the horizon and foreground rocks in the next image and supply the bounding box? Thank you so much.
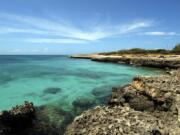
[0,56,163,110]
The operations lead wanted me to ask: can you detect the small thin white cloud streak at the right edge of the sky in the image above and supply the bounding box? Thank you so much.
[144,31,179,36]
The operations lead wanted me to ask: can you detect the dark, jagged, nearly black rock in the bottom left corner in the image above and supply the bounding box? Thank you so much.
[0,102,35,134]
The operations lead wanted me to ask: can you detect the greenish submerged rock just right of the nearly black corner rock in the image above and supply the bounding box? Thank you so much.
[30,105,73,135]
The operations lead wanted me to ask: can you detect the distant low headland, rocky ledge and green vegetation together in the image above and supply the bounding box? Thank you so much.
[70,44,180,69]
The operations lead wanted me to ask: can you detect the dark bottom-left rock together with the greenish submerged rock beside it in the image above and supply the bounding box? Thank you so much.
[0,102,73,135]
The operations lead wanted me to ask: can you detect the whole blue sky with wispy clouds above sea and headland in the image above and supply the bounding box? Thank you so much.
[0,0,180,54]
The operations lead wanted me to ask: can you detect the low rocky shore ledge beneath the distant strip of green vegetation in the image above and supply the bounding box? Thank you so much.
[70,54,180,69]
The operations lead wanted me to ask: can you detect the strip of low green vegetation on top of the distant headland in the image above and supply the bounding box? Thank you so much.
[100,44,180,55]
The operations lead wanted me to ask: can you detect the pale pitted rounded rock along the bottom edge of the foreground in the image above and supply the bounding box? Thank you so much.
[65,106,180,135]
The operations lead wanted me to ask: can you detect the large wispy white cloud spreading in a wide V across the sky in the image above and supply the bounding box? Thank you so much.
[0,14,152,43]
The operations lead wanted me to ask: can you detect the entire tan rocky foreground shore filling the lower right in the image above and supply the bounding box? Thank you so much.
[65,71,180,135]
